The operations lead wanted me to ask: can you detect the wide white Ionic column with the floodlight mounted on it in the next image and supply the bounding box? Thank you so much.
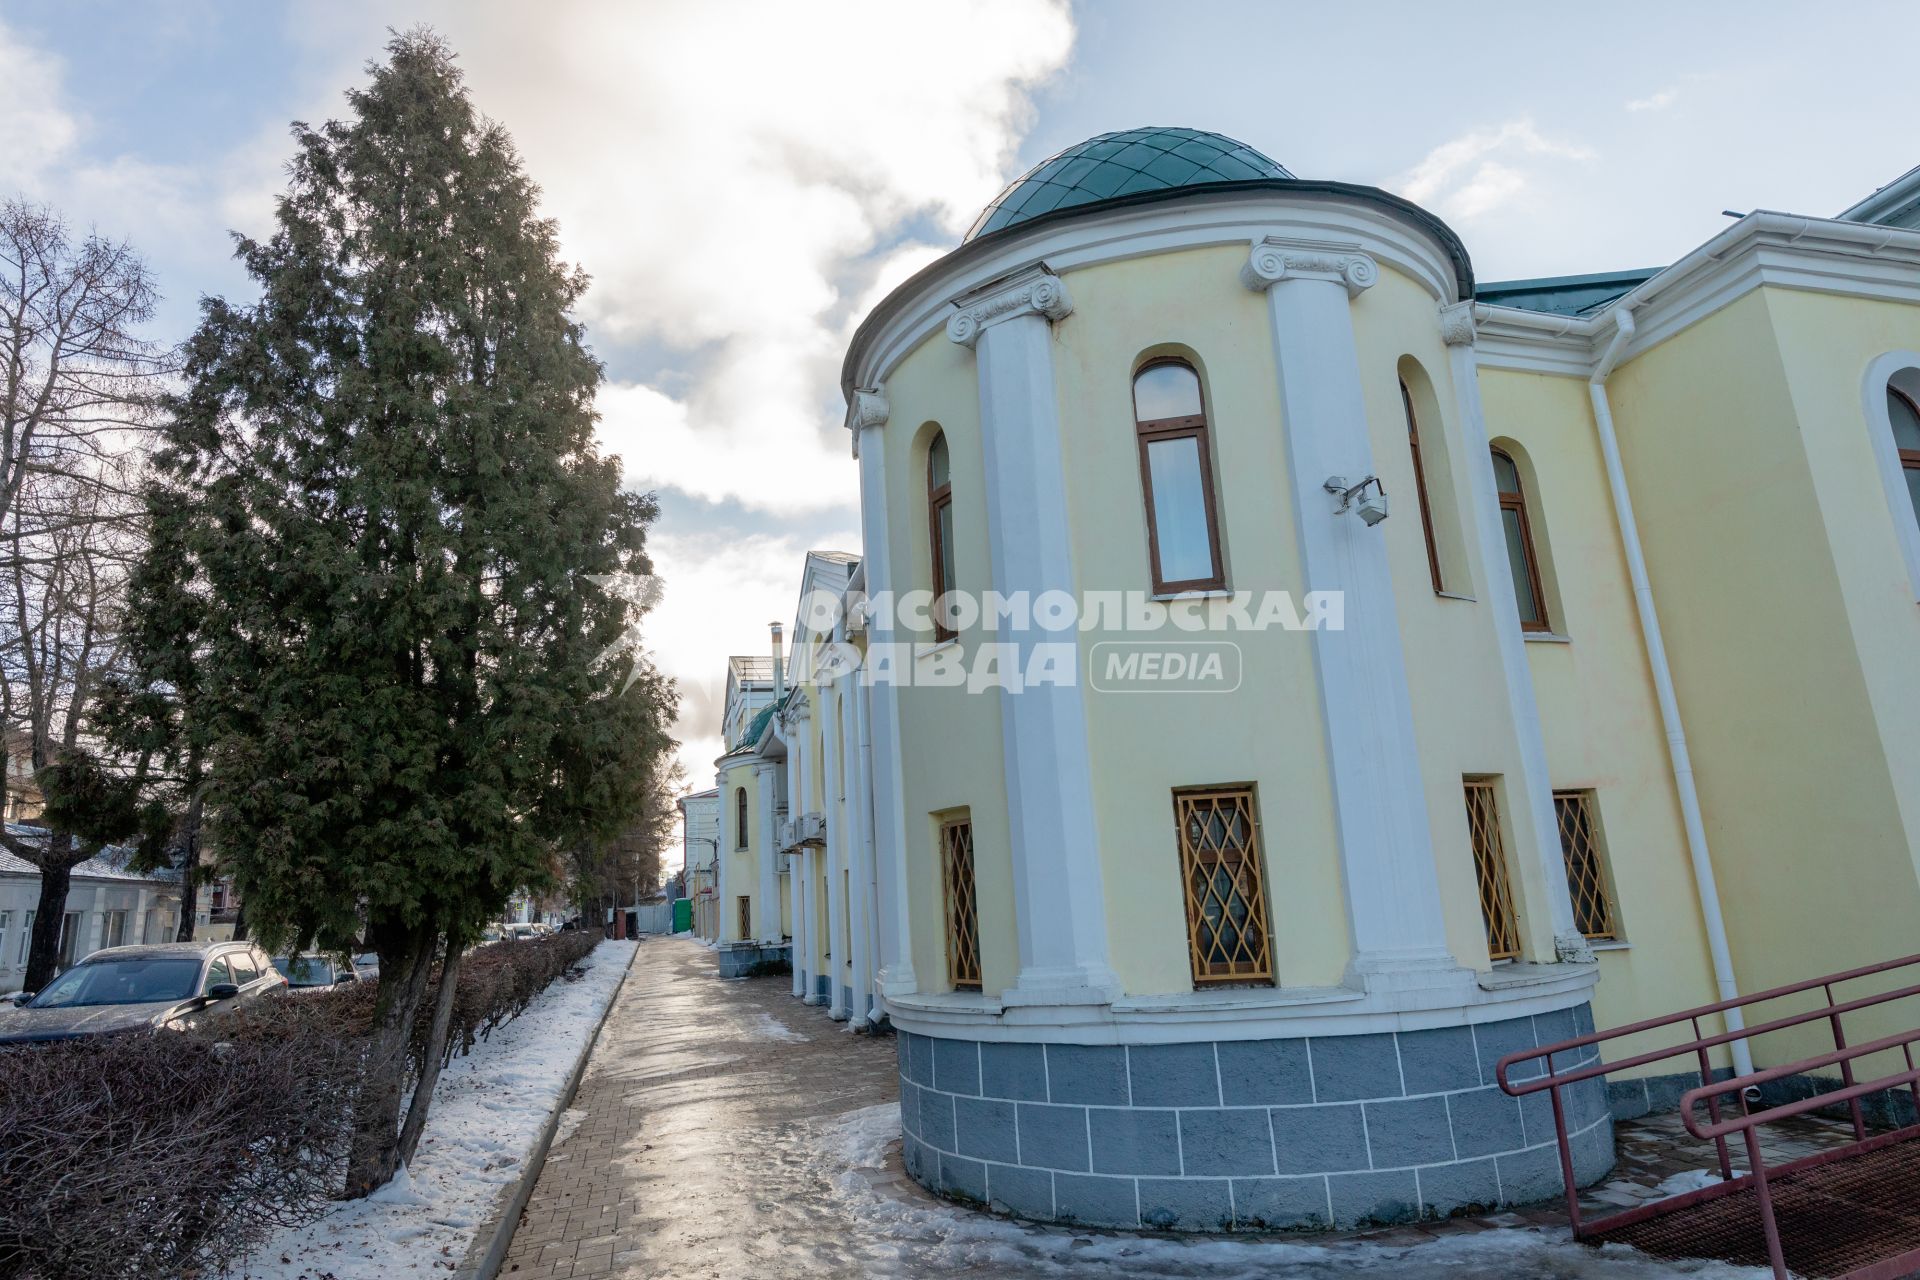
[1242,238,1457,986]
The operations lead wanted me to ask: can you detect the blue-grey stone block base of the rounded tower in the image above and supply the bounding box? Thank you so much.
[899,1006,1613,1232]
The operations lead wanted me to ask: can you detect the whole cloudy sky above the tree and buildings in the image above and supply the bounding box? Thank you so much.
[0,0,1920,805]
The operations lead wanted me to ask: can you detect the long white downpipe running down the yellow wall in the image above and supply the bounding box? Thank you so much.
[1588,307,1753,1075]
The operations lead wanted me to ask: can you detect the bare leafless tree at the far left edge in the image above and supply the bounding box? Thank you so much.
[0,201,163,990]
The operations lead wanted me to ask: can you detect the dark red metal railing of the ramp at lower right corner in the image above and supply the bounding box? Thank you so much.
[1494,956,1920,1280]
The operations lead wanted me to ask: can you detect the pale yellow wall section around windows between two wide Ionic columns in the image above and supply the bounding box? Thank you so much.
[1054,248,1348,994]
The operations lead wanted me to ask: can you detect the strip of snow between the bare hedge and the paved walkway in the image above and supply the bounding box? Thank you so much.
[240,942,636,1280]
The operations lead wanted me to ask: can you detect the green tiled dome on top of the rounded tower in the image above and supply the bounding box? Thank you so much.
[966,129,1294,240]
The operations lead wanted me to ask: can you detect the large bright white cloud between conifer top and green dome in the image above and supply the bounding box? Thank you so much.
[345,0,1073,514]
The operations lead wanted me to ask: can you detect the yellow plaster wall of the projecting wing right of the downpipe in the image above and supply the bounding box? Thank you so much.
[1611,290,1920,1063]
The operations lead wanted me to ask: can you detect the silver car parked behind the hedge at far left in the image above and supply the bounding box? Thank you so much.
[0,942,286,1044]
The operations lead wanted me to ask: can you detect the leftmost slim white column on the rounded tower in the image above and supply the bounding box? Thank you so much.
[847,388,920,996]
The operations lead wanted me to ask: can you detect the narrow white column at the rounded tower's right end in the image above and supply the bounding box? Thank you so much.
[1440,299,1594,961]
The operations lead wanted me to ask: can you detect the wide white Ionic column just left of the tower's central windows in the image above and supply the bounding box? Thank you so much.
[947,265,1119,1004]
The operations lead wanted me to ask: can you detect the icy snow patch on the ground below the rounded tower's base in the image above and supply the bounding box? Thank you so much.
[810,1103,1770,1280]
